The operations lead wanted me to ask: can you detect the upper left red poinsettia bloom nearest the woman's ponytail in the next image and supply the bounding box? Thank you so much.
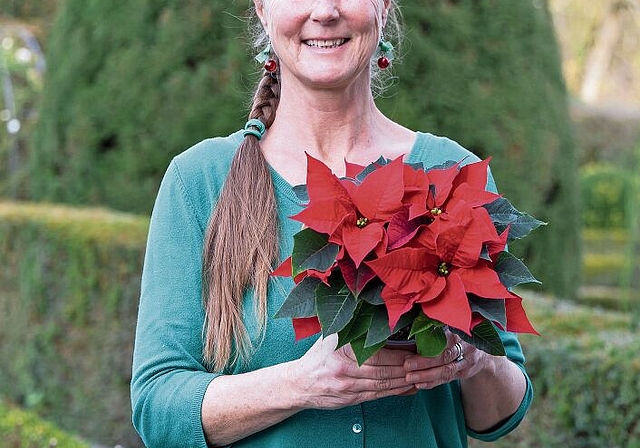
[292,155,404,268]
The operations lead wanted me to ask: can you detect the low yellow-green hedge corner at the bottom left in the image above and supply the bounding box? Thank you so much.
[0,401,89,448]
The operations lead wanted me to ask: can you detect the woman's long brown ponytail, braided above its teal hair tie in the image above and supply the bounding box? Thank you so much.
[203,69,280,371]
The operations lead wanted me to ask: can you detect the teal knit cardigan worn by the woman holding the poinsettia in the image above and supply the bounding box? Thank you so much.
[131,132,533,448]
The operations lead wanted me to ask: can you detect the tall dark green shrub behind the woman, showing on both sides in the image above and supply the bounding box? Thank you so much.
[30,0,580,296]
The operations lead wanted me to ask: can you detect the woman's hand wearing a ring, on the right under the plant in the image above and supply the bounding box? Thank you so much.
[404,332,491,389]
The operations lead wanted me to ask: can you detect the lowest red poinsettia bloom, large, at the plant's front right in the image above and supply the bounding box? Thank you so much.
[366,202,512,333]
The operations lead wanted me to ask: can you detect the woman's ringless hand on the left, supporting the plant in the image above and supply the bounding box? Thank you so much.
[295,334,415,409]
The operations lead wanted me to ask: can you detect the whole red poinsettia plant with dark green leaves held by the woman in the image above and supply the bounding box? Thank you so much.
[273,155,544,364]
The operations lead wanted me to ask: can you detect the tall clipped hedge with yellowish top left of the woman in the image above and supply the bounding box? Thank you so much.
[0,202,148,447]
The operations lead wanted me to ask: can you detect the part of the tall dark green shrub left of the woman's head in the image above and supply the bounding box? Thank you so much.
[30,0,250,213]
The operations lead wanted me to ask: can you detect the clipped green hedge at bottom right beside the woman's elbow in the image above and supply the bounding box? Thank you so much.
[470,299,640,448]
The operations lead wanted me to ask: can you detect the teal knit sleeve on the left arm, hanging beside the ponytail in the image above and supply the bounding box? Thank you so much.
[131,160,216,448]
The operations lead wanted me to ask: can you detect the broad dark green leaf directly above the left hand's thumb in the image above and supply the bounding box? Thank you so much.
[316,282,357,337]
